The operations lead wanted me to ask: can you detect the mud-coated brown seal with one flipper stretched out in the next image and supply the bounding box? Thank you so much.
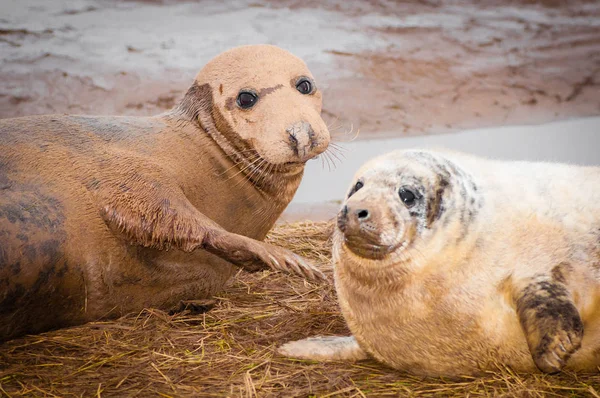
[0,45,329,340]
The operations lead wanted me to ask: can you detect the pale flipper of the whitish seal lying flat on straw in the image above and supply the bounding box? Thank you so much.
[277,336,367,361]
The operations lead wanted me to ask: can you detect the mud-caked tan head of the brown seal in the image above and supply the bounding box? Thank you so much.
[179,45,330,172]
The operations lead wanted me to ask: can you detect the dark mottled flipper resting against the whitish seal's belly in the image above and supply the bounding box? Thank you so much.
[515,279,583,373]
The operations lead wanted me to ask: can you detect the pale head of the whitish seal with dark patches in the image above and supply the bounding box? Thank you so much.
[337,151,460,262]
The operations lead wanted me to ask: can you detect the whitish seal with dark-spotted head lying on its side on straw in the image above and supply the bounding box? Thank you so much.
[280,151,600,376]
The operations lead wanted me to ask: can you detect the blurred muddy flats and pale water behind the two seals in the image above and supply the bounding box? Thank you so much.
[0,0,600,218]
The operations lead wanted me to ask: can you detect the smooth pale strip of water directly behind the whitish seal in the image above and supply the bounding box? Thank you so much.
[283,117,600,221]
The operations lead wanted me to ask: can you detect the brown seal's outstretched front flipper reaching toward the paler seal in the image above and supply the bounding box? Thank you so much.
[96,165,326,280]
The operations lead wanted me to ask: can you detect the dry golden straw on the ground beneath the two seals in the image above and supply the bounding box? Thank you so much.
[0,223,600,397]
